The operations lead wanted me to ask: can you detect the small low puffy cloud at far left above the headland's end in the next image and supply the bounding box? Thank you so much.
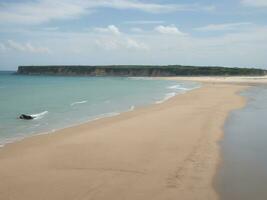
[4,40,50,53]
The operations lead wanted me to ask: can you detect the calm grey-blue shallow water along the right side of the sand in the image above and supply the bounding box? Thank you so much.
[216,86,267,200]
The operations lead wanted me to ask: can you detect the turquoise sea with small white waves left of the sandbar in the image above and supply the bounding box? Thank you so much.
[0,72,198,145]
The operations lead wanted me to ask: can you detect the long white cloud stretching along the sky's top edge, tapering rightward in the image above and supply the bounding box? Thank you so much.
[0,0,214,24]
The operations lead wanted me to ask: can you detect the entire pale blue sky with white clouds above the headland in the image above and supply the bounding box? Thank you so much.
[0,0,267,70]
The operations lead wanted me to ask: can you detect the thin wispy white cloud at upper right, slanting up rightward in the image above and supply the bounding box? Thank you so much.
[195,22,251,31]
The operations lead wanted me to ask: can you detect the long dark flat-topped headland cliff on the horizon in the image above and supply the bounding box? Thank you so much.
[17,65,266,77]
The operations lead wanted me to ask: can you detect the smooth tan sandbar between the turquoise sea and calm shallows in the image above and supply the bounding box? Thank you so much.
[0,80,251,200]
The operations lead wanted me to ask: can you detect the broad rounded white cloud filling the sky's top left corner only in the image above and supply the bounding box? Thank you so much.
[0,0,86,24]
